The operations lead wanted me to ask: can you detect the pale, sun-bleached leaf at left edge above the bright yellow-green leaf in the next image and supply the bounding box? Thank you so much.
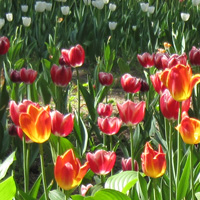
[0,151,16,180]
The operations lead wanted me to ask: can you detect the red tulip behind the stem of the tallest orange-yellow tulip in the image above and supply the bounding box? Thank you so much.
[160,89,190,120]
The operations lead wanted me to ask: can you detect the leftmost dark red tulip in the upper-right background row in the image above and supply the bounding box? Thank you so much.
[137,52,154,68]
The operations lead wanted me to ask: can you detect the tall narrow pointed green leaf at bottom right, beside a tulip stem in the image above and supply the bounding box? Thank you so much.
[177,154,191,200]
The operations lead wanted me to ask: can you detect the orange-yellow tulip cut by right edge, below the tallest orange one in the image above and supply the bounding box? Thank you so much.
[176,112,200,144]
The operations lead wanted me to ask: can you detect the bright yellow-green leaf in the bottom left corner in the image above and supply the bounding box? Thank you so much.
[0,176,16,200]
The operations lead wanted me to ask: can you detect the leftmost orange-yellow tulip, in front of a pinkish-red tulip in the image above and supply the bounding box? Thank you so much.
[19,104,51,143]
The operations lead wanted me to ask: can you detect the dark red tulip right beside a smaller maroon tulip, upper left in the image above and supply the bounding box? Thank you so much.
[20,68,37,84]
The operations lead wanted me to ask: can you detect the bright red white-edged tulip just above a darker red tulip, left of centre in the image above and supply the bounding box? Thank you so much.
[61,44,85,67]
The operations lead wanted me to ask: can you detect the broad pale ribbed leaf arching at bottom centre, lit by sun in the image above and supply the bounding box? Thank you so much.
[105,171,143,194]
